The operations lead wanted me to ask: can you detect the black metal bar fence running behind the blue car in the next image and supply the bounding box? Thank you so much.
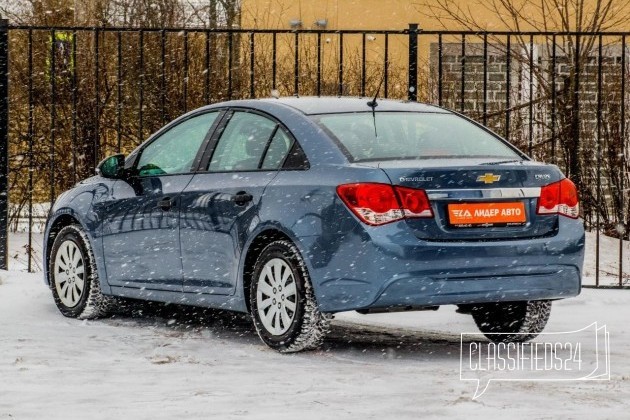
[0,21,630,286]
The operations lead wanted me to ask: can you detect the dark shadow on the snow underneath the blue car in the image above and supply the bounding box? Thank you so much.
[105,300,467,360]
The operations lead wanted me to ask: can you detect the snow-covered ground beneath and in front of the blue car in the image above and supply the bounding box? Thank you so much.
[0,271,630,420]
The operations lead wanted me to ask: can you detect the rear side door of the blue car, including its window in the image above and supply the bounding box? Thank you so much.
[180,110,292,294]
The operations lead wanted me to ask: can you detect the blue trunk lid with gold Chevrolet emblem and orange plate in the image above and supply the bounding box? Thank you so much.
[363,158,563,241]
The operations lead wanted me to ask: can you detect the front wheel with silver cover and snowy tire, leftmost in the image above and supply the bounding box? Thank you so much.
[48,225,114,319]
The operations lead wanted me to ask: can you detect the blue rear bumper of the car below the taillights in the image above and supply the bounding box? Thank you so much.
[302,217,584,312]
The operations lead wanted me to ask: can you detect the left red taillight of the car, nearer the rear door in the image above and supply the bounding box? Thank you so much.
[337,183,433,225]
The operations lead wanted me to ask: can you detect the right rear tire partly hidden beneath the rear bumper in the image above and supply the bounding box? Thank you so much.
[471,300,551,343]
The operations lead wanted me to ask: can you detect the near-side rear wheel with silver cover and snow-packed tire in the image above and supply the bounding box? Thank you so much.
[250,240,330,353]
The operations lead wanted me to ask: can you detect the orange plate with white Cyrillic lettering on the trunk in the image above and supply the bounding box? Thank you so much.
[448,202,527,227]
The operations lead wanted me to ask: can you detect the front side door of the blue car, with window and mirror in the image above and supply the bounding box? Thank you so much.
[102,111,220,291]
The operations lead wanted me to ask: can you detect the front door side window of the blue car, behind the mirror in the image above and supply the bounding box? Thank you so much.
[137,111,219,176]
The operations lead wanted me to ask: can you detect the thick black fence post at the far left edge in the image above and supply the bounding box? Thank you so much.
[0,16,9,270]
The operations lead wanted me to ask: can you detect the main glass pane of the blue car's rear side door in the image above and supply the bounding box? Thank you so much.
[208,111,277,172]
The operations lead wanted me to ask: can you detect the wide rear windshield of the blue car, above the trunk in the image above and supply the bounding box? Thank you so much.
[313,112,523,162]
